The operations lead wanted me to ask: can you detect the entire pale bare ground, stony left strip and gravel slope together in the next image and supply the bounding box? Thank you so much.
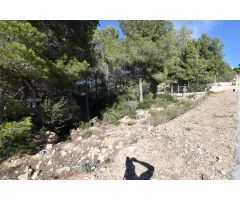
[0,90,237,180]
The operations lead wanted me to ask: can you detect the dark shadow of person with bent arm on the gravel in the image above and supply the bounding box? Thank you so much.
[123,157,154,180]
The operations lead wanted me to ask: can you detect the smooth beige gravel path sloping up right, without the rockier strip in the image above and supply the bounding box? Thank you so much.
[94,90,237,180]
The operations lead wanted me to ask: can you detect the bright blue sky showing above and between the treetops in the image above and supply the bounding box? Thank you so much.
[100,20,240,67]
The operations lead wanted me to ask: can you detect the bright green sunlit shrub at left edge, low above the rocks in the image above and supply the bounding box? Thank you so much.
[0,117,33,161]
